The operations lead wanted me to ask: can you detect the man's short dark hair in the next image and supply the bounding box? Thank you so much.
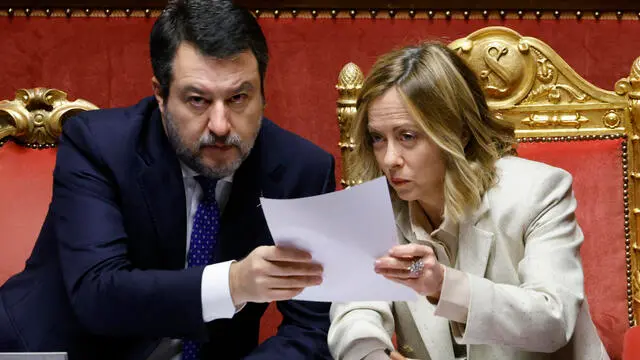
[149,0,269,99]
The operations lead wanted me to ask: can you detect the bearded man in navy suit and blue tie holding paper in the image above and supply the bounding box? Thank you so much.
[0,0,335,360]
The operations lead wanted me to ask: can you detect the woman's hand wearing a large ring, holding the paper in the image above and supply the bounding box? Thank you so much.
[375,244,444,299]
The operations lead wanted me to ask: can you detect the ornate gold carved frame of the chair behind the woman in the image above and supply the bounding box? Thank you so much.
[337,27,640,326]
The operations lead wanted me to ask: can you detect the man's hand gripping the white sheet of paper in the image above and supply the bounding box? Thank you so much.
[229,246,322,307]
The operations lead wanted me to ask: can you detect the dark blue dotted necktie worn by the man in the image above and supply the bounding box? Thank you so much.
[182,176,220,360]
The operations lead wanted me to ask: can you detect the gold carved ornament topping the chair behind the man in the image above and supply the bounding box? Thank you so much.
[0,88,98,148]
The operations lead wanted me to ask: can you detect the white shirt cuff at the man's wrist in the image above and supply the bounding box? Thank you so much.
[201,261,236,322]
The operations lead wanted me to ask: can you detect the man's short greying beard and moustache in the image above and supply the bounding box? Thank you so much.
[164,106,262,179]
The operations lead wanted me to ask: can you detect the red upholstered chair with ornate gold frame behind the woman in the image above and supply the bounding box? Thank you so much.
[337,27,640,359]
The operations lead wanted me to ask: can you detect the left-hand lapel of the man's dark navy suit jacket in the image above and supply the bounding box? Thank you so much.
[138,105,187,269]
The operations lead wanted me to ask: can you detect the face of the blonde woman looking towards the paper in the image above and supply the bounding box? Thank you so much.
[368,87,445,202]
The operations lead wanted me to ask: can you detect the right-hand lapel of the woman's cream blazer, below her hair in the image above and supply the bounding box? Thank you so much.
[457,196,494,277]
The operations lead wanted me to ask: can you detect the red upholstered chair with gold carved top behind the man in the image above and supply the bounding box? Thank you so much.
[0,88,282,342]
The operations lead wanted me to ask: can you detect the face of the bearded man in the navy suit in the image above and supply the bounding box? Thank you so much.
[153,43,264,178]
